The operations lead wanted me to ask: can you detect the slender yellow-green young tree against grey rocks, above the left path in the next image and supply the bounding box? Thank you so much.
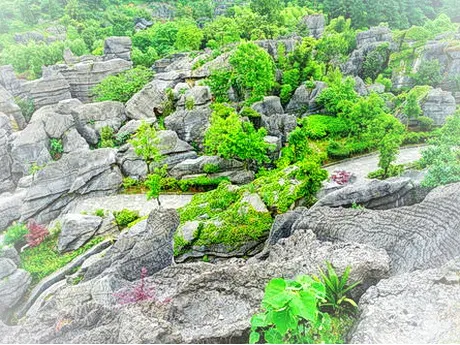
[128,121,163,175]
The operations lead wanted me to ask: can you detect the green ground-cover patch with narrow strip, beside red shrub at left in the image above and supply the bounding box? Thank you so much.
[19,234,103,285]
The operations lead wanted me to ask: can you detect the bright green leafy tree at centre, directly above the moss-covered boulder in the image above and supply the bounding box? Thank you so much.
[204,104,271,169]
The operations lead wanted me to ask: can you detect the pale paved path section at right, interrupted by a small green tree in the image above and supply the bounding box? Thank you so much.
[326,146,425,180]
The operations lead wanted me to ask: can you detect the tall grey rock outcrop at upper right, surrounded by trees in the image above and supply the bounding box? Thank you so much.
[342,26,395,77]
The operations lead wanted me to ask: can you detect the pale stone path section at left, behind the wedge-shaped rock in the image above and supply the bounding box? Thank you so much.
[70,194,193,216]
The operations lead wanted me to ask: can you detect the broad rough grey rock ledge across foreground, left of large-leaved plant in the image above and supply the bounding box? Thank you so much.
[0,226,388,343]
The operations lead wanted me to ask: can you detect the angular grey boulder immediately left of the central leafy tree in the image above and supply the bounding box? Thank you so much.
[165,107,212,145]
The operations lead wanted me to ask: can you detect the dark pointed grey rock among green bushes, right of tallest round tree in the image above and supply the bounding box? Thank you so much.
[286,81,327,115]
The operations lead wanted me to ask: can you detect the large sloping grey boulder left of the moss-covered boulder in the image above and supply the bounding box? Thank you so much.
[85,208,179,281]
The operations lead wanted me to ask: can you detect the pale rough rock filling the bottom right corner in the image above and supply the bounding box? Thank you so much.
[351,257,460,344]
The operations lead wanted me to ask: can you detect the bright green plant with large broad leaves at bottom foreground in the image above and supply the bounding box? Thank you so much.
[249,276,337,344]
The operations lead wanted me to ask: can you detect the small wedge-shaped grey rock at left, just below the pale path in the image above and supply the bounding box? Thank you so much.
[58,214,102,253]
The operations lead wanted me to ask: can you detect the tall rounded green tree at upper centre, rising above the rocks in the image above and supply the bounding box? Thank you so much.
[229,43,275,103]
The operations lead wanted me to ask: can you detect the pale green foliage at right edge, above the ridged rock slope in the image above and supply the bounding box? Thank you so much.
[420,111,460,187]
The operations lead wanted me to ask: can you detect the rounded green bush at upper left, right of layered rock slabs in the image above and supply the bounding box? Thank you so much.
[93,66,153,103]
